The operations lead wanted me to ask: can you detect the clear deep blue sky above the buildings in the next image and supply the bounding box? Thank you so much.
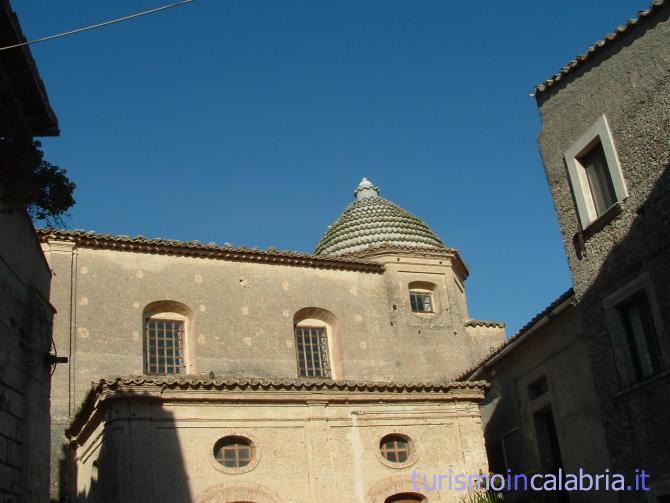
[12,0,648,335]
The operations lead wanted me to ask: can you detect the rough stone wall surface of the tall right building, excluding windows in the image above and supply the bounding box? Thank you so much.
[538,4,670,501]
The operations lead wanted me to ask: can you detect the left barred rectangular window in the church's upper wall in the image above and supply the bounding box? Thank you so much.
[145,318,184,374]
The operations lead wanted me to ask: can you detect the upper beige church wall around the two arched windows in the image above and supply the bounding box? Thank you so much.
[43,240,504,500]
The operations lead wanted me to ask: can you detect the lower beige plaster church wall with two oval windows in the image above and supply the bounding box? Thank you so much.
[69,384,487,503]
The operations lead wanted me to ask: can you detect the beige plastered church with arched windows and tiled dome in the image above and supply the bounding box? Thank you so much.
[39,179,505,503]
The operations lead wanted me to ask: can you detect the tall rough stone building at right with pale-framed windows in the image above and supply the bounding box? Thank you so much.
[535,0,670,501]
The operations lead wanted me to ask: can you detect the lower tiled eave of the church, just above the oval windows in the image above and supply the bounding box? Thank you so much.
[68,375,489,435]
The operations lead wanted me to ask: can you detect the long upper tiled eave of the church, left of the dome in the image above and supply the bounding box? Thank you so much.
[37,229,384,273]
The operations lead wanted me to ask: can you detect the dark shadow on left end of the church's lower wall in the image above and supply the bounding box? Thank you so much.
[67,393,192,503]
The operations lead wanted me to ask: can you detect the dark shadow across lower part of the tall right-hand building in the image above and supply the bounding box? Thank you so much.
[578,156,670,490]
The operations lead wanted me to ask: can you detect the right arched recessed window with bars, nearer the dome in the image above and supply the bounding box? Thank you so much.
[293,307,342,379]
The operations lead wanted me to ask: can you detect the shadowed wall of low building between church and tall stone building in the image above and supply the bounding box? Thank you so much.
[477,305,616,503]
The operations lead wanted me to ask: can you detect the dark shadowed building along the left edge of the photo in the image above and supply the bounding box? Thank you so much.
[0,0,58,503]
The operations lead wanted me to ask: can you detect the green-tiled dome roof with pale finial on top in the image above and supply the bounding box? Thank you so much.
[314,178,446,255]
